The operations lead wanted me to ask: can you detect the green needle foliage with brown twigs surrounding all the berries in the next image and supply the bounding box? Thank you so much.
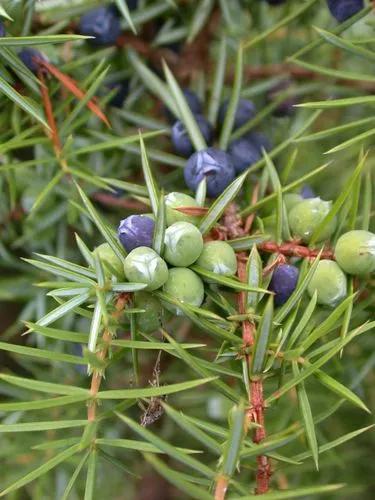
[0,0,375,500]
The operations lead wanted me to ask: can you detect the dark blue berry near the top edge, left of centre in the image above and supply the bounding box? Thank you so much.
[79,7,121,45]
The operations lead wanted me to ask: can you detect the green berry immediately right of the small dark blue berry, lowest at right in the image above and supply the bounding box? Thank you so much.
[307,260,346,307]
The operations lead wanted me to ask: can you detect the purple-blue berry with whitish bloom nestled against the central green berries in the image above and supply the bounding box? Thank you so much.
[118,215,155,252]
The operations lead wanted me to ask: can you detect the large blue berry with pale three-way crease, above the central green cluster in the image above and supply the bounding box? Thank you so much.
[184,148,235,198]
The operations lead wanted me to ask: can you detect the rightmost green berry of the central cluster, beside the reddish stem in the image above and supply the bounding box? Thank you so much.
[196,241,237,276]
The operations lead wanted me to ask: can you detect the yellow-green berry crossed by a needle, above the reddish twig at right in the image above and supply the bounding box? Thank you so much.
[289,198,336,243]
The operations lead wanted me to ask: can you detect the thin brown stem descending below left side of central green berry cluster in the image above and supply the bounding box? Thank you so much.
[87,293,129,422]
